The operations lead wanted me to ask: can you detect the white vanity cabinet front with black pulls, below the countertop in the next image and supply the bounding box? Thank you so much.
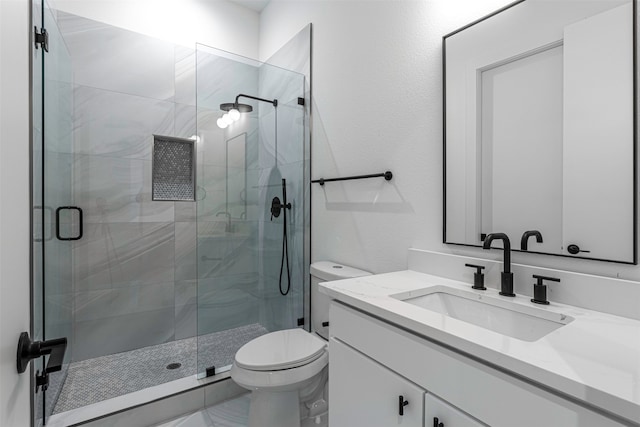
[329,301,630,427]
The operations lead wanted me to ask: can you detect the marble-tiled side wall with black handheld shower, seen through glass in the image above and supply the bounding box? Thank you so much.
[258,64,305,330]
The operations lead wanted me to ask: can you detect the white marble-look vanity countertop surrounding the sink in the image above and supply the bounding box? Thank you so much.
[320,270,640,423]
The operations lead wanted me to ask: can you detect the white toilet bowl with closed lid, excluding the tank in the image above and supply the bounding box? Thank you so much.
[231,329,329,427]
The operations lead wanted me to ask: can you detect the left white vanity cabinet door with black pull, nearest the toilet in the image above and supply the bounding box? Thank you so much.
[329,338,425,427]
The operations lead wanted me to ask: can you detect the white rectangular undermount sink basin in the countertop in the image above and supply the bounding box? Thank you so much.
[392,286,573,341]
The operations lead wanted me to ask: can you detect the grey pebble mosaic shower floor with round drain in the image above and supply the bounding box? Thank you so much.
[54,323,268,414]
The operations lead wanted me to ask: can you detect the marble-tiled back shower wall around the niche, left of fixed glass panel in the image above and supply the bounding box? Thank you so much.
[58,13,197,361]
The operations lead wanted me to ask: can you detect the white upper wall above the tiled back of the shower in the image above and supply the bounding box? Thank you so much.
[51,0,259,58]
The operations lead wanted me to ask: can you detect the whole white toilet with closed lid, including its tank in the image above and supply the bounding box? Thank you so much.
[231,261,371,427]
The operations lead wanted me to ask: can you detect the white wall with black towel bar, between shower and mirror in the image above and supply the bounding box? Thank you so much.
[260,0,640,280]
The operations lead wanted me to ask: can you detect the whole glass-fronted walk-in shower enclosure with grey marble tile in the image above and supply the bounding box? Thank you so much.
[31,0,309,425]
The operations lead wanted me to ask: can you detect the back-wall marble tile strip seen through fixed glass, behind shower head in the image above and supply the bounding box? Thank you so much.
[197,51,262,344]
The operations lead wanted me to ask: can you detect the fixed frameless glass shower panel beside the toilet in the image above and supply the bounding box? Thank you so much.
[196,45,305,376]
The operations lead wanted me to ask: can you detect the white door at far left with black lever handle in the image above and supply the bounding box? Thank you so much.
[0,0,30,427]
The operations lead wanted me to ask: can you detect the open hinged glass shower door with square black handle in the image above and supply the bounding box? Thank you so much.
[32,1,74,425]
